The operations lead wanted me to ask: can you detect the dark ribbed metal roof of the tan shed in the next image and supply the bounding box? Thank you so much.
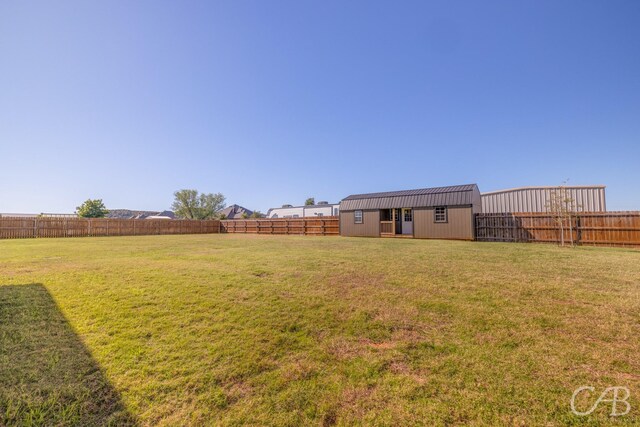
[340,184,478,211]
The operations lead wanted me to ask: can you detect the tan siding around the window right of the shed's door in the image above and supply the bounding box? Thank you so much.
[413,206,474,240]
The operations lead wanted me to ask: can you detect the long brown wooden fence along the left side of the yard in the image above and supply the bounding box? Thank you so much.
[0,217,220,239]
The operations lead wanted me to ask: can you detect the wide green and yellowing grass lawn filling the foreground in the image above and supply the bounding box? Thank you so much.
[0,235,640,426]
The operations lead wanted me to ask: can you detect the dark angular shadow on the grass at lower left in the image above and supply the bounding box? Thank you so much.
[0,284,137,426]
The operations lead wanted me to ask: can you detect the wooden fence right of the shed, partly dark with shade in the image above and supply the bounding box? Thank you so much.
[475,212,640,246]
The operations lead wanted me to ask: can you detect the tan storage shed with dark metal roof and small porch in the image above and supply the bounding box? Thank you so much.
[340,184,482,240]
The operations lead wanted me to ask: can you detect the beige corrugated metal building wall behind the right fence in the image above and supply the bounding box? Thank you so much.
[482,185,607,213]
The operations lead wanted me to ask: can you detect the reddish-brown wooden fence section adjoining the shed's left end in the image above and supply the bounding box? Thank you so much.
[220,216,340,236]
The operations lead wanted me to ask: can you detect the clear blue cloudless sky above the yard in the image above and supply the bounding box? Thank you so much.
[0,0,640,213]
